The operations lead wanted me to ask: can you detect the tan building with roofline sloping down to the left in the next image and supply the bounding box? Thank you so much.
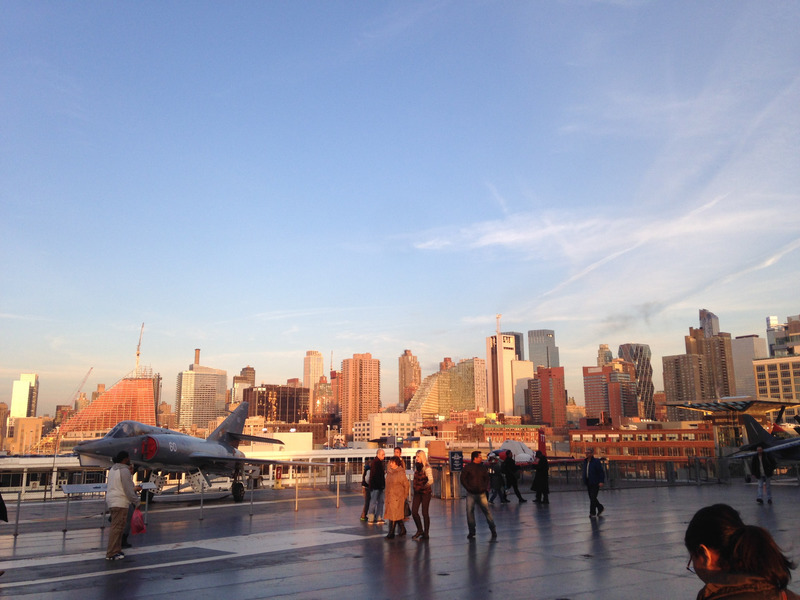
[406,358,486,419]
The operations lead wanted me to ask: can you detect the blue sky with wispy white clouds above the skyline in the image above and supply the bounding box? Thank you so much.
[0,0,800,414]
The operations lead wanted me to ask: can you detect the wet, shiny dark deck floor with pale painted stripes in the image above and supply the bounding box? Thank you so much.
[0,482,800,600]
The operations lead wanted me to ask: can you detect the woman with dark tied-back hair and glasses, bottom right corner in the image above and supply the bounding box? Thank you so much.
[684,504,800,600]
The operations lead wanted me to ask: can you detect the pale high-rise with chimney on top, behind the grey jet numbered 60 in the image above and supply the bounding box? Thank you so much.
[175,348,228,428]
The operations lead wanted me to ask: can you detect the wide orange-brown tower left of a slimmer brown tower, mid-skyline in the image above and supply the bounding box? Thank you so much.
[339,353,381,439]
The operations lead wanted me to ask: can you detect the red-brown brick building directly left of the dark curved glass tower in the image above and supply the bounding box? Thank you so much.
[583,358,638,427]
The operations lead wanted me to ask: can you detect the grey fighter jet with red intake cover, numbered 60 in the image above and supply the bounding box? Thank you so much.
[74,402,330,502]
